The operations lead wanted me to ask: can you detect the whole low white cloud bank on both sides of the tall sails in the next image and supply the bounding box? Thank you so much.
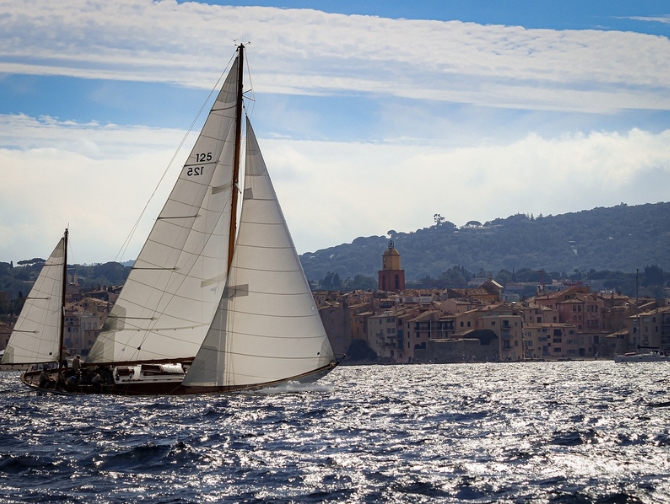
[0,116,670,262]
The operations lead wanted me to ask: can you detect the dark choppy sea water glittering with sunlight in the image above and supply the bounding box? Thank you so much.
[0,361,670,503]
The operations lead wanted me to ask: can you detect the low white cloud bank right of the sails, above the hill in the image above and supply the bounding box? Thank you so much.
[270,129,670,252]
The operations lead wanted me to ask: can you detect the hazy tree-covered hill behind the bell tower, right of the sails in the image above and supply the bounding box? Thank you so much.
[300,203,670,281]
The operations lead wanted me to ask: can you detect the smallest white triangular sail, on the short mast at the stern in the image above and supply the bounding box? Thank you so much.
[2,238,65,364]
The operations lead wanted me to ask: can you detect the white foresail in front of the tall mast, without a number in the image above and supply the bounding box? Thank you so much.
[184,119,334,386]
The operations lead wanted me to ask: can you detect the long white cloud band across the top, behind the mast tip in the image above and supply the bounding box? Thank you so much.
[0,0,670,111]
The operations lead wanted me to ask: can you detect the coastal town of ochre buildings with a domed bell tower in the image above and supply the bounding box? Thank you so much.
[0,241,670,364]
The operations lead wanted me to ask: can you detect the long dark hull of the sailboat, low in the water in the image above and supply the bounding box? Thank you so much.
[21,362,338,396]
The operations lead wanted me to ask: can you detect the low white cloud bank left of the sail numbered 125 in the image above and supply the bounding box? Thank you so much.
[0,115,188,263]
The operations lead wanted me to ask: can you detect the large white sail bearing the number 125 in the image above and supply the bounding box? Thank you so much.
[87,59,238,362]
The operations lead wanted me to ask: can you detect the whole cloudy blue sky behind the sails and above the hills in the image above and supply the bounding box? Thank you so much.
[0,0,670,263]
